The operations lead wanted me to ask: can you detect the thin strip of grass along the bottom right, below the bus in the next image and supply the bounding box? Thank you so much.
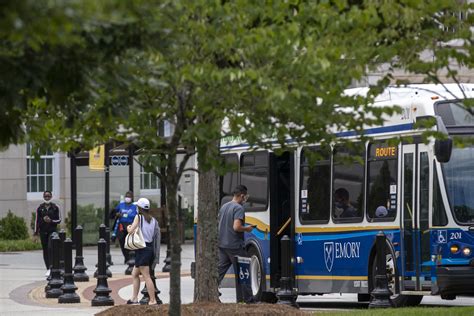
[322,306,474,316]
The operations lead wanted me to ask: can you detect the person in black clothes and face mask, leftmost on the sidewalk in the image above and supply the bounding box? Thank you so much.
[34,191,61,276]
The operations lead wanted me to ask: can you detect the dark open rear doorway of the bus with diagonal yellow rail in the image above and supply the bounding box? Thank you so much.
[270,151,295,288]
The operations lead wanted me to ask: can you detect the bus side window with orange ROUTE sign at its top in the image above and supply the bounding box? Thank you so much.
[367,143,398,222]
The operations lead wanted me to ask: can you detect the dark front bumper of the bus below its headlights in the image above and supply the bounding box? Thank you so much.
[436,262,474,296]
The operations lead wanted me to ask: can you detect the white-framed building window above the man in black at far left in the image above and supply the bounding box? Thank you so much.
[26,144,54,193]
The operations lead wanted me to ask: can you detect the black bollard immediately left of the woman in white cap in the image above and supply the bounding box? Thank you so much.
[91,238,114,306]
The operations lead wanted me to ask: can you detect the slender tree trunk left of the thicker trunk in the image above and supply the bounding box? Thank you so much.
[166,155,181,316]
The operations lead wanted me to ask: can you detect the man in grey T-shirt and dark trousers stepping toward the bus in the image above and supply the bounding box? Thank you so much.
[218,185,254,303]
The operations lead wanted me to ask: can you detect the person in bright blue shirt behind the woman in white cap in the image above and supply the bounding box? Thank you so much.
[111,191,138,264]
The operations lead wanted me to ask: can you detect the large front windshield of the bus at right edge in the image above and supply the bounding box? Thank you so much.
[441,139,474,225]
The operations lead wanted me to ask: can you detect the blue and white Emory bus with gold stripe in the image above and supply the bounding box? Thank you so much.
[216,84,474,306]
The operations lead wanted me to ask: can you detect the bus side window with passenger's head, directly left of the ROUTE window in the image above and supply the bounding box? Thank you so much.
[332,143,364,223]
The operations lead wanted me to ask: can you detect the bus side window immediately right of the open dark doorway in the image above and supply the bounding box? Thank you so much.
[300,147,331,224]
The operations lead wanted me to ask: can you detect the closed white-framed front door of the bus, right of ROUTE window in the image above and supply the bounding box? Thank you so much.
[401,144,431,291]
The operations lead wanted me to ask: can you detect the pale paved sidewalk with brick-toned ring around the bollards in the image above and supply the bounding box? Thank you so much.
[0,243,204,316]
